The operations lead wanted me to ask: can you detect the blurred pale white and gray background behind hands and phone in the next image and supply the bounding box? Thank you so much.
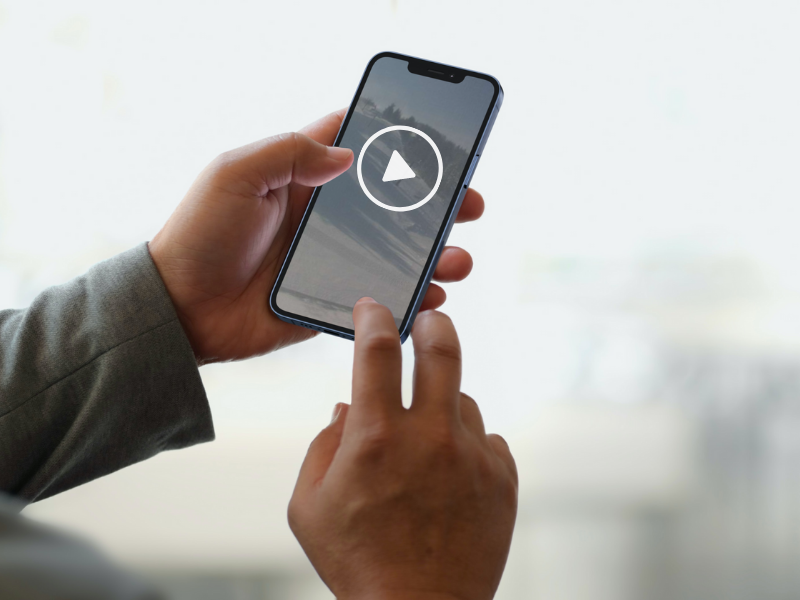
[0,0,800,600]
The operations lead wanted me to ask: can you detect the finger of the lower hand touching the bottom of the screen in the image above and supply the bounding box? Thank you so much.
[349,298,403,424]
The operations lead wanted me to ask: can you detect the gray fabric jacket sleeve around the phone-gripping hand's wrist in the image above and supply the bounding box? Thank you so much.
[0,244,214,501]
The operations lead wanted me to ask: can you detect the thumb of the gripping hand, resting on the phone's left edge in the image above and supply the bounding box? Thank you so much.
[218,133,353,196]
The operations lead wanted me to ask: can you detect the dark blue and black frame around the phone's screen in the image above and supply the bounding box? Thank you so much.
[269,52,504,343]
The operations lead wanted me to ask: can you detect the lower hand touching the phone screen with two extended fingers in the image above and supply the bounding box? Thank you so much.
[289,299,517,600]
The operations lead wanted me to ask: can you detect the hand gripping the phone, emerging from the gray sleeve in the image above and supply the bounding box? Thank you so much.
[150,110,483,364]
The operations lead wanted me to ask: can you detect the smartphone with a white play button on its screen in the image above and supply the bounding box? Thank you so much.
[269,52,503,341]
